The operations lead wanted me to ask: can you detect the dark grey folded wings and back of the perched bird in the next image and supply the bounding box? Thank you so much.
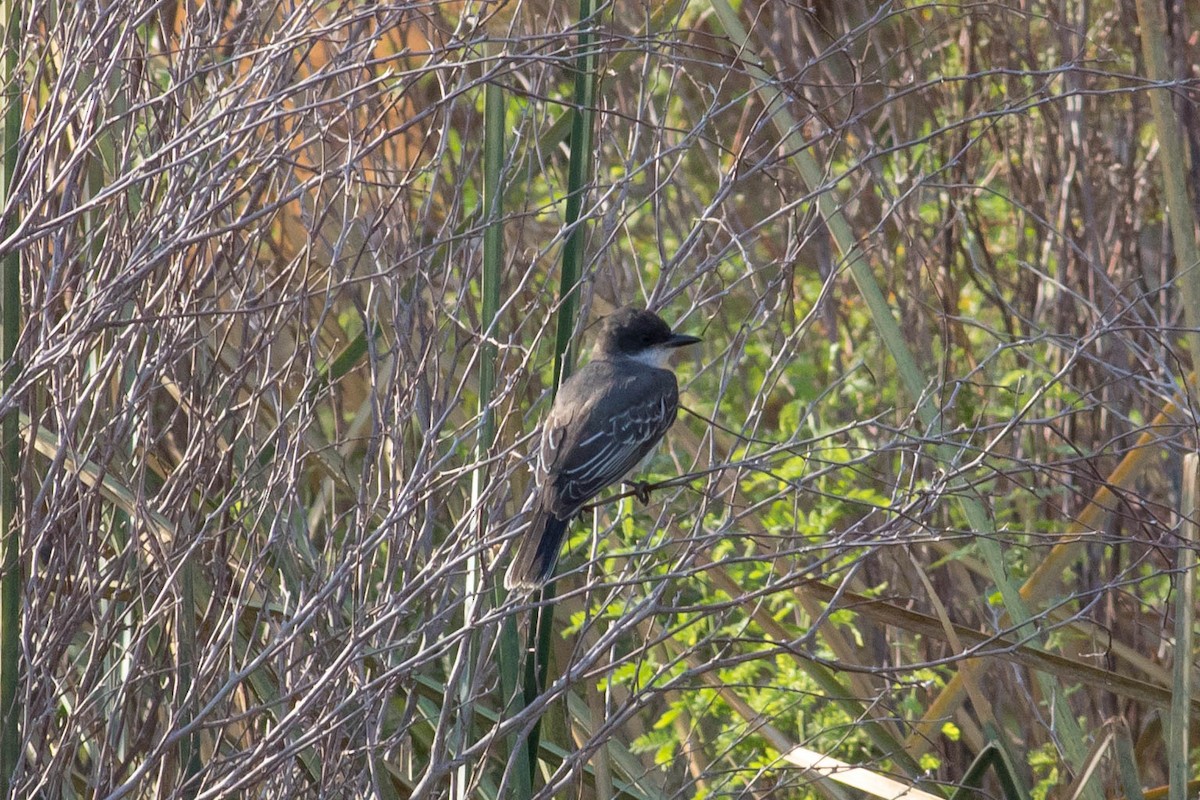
[539,365,679,519]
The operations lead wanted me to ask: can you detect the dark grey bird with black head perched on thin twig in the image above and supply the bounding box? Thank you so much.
[504,308,700,589]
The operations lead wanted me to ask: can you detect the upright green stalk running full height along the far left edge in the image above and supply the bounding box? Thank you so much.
[0,0,22,798]
